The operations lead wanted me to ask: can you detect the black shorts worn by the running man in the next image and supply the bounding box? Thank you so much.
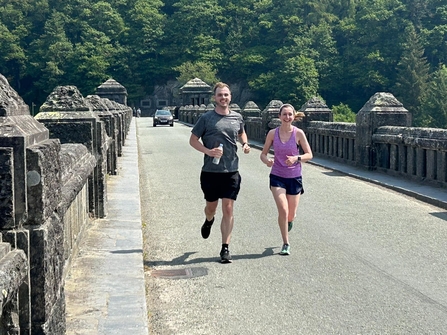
[200,171,241,202]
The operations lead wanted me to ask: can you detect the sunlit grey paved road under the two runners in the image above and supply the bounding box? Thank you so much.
[137,118,447,335]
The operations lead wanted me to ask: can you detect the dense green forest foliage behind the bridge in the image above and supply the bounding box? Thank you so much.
[0,0,447,128]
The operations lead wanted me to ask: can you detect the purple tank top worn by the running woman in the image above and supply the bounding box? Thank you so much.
[271,127,301,178]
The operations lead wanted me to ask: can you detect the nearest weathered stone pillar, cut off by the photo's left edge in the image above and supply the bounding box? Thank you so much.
[0,75,65,334]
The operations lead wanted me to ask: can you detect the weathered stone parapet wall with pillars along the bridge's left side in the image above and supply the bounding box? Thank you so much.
[0,75,132,334]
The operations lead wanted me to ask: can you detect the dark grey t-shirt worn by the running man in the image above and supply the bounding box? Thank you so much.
[191,110,244,172]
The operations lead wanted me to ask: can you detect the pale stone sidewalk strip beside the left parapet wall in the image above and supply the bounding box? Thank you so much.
[65,119,148,335]
